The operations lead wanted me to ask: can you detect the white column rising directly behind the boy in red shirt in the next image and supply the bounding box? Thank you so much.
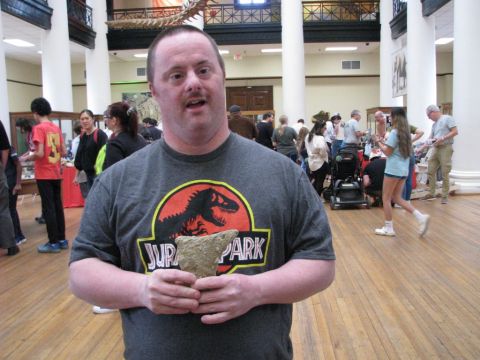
[42,0,73,111]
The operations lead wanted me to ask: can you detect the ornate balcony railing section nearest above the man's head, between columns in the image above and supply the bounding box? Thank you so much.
[203,4,281,25]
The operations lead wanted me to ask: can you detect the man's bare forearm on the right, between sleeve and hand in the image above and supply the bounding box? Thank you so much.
[254,259,335,305]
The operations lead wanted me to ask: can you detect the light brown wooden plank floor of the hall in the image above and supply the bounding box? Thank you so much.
[0,195,480,360]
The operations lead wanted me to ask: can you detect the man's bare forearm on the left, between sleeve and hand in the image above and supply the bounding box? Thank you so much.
[70,258,147,309]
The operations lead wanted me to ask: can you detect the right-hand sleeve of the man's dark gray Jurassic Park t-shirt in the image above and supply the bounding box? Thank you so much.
[287,173,335,260]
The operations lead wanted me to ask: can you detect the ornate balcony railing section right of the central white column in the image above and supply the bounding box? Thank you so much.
[303,0,380,22]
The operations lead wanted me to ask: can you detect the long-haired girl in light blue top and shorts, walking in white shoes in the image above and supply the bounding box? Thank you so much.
[375,108,430,236]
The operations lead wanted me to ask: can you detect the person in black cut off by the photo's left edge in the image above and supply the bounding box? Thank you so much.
[0,121,20,256]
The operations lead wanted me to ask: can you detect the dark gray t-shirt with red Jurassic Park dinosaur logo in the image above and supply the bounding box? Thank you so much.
[70,134,335,360]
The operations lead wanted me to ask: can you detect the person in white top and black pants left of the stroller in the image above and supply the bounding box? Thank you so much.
[305,121,330,196]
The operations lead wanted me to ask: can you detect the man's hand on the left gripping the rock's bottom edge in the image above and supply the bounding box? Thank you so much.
[142,269,200,314]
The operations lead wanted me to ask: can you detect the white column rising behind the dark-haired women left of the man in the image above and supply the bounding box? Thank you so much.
[85,0,112,114]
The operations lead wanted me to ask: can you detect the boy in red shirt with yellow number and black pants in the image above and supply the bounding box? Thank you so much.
[24,98,68,253]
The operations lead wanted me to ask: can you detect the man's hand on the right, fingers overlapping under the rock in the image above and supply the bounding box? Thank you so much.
[193,274,260,324]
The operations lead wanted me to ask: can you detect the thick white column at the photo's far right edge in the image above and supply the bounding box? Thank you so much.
[450,0,480,193]
